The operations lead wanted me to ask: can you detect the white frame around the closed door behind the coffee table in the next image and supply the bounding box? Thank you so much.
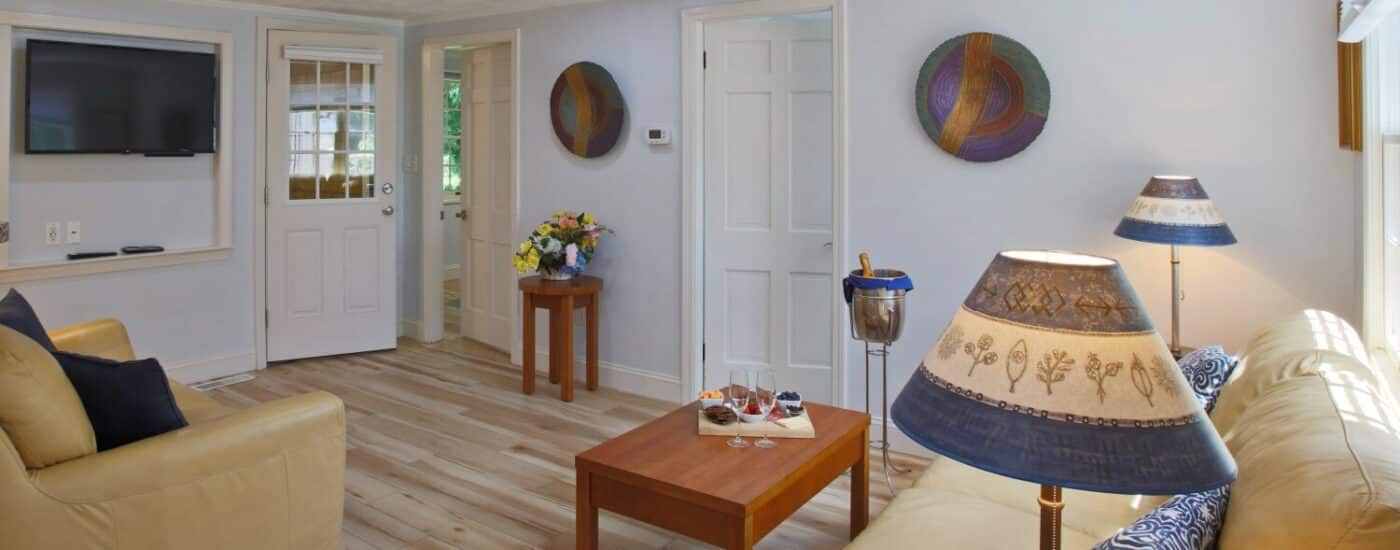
[679,0,850,406]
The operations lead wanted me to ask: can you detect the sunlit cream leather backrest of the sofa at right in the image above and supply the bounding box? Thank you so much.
[1212,312,1400,549]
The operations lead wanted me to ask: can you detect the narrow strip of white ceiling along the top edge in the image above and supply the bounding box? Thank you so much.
[219,0,598,22]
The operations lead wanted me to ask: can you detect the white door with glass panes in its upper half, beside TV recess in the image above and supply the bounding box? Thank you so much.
[267,31,399,361]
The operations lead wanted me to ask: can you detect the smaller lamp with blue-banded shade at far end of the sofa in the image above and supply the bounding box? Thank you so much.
[1113,176,1235,358]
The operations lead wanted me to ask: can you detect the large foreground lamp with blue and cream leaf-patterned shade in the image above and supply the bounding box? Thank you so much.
[890,251,1236,550]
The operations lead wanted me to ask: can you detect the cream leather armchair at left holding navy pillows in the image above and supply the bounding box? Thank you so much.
[0,320,346,550]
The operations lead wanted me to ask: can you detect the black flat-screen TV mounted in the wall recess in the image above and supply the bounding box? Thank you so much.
[25,39,218,154]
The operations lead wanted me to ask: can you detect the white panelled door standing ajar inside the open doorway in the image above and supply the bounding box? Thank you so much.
[458,43,517,350]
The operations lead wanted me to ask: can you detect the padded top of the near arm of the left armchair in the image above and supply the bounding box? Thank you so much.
[31,392,346,504]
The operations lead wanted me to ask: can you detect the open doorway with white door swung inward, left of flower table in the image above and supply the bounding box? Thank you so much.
[423,31,518,351]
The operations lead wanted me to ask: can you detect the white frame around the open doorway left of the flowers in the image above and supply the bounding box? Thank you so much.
[417,28,524,355]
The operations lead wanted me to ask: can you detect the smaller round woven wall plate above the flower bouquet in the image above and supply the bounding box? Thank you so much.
[549,62,624,158]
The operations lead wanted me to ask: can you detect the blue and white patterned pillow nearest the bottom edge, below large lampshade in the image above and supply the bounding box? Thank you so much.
[1093,487,1229,550]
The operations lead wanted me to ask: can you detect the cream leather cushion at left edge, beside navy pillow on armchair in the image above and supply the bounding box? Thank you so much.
[0,326,97,469]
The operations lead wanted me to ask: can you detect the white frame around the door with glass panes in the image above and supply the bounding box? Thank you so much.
[253,15,403,369]
